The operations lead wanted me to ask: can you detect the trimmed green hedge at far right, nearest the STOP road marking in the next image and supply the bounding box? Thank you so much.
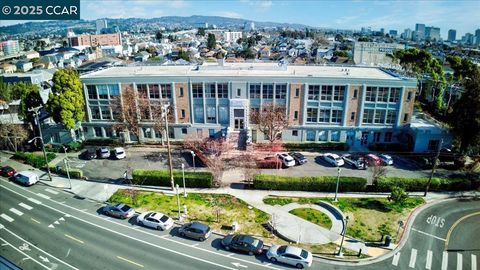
[376,176,477,192]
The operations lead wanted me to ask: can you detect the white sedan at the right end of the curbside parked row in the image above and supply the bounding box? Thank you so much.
[267,245,313,269]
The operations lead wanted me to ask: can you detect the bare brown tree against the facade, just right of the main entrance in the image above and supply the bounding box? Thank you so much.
[250,103,288,143]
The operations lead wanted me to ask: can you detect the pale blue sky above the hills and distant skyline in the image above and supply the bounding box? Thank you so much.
[4,0,480,38]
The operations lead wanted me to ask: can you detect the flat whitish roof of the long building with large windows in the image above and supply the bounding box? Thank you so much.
[82,63,414,81]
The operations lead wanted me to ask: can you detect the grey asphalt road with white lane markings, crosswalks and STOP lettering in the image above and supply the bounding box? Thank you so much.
[0,175,480,270]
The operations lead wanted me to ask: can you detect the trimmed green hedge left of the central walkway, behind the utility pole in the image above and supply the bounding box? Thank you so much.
[132,170,213,188]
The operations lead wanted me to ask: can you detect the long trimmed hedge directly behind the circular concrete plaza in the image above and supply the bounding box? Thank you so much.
[253,174,367,192]
